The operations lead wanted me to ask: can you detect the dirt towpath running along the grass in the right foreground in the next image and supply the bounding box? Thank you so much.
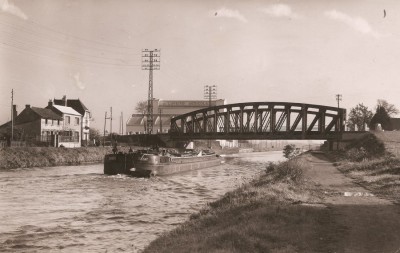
[306,154,400,253]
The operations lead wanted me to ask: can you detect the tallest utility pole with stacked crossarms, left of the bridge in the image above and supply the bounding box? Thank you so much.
[142,49,160,134]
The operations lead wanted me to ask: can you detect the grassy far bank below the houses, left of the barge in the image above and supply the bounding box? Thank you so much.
[0,147,111,169]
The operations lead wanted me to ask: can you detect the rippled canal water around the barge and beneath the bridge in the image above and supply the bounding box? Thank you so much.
[0,151,283,252]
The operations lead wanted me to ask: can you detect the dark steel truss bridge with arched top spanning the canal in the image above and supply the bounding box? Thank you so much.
[169,102,346,140]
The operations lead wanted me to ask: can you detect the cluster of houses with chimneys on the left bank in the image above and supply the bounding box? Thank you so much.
[0,96,90,147]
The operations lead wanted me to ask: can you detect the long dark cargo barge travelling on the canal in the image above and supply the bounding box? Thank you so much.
[104,150,222,177]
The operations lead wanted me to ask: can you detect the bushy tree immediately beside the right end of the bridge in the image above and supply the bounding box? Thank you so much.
[347,103,373,131]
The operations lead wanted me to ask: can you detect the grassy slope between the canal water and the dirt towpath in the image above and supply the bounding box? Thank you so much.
[144,156,340,252]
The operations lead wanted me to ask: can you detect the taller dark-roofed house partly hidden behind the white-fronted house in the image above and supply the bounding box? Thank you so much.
[53,95,91,145]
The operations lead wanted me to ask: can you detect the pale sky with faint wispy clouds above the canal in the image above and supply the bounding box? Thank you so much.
[0,0,400,131]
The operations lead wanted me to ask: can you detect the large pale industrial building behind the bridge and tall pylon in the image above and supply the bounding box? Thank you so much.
[126,99,225,134]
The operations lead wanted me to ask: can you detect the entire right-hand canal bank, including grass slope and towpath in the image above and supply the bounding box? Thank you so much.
[144,133,400,252]
